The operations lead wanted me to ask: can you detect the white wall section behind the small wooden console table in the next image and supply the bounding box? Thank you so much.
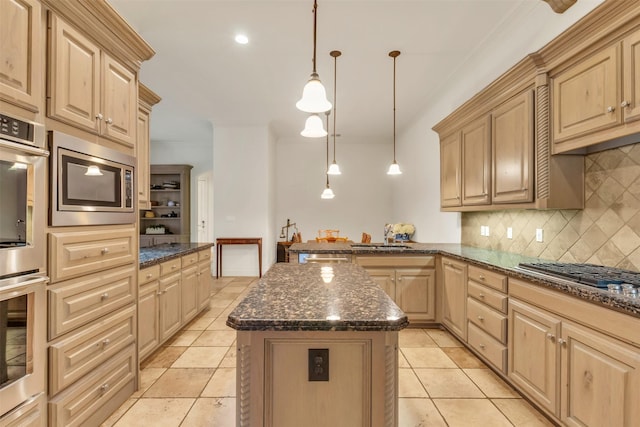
[213,126,275,276]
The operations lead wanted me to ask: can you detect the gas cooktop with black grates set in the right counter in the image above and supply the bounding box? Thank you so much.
[518,262,640,288]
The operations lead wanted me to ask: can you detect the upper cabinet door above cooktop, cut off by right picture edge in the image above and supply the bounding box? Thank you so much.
[621,31,640,122]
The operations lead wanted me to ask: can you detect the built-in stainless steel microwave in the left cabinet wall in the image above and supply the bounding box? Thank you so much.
[49,131,136,226]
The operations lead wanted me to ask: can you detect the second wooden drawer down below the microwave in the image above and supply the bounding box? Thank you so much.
[48,265,136,340]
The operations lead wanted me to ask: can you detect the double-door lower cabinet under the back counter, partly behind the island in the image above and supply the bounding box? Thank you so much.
[356,255,436,323]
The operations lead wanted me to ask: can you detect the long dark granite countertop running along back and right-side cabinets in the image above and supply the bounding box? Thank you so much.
[289,242,640,317]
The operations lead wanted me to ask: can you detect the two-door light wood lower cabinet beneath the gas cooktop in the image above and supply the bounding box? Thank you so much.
[509,281,640,426]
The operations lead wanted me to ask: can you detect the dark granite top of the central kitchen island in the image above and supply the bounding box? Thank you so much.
[227,263,409,331]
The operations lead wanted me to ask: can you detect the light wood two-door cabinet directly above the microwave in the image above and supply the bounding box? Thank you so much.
[47,13,138,147]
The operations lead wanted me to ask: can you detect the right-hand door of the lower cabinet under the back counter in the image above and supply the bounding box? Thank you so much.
[396,268,436,320]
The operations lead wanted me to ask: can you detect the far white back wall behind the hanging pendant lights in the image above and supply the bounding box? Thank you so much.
[275,137,402,242]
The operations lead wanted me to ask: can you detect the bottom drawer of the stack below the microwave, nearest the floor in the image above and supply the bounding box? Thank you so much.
[49,344,136,427]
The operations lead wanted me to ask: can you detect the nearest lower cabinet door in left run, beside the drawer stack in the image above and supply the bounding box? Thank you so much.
[138,280,160,360]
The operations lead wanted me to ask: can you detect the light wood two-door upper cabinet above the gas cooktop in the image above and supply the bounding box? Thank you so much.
[551,26,640,153]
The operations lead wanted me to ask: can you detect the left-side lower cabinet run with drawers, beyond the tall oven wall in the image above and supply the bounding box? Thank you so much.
[138,248,212,361]
